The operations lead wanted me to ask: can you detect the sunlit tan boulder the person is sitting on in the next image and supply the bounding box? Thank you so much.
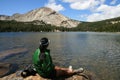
[0,71,99,80]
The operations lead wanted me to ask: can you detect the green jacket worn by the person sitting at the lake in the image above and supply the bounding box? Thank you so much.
[33,48,54,77]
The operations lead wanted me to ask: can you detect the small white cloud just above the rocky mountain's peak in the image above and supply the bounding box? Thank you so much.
[45,0,65,12]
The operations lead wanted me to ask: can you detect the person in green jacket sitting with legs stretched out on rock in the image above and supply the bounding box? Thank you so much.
[33,38,83,79]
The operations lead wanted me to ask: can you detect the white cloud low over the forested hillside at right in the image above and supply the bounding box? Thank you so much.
[87,4,120,21]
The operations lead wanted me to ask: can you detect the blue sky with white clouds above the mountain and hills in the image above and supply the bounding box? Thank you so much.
[0,0,120,22]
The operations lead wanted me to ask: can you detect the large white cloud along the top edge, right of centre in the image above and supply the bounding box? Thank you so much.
[62,0,105,10]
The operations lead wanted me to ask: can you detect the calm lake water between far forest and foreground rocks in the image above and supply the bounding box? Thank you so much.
[0,32,120,80]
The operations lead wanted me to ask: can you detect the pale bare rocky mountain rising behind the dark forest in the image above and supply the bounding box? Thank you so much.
[0,7,80,28]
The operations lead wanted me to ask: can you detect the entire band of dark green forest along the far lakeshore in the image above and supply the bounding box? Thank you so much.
[0,17,120,32]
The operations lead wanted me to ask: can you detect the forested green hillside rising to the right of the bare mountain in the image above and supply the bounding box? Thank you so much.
[73,17,120,32]
